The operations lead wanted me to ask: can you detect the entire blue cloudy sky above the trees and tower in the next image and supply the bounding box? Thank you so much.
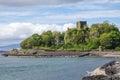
[0,0,120,46]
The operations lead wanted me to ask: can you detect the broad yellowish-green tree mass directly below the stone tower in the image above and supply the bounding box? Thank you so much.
[64,25,89,45]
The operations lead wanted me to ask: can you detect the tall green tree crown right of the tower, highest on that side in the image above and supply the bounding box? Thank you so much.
[89,21,119,38]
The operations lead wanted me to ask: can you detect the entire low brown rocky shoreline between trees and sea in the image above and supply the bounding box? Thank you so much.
[2,49,120,58]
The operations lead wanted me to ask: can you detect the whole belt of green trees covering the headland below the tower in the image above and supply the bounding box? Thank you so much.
[20,21,120,50]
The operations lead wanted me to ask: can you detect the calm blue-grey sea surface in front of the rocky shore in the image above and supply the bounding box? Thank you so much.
[0,53,115,80]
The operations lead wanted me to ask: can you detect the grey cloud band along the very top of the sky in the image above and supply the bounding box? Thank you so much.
[0,0,120,7]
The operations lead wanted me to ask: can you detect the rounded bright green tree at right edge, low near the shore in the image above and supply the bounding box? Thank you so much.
[100,31,120,49]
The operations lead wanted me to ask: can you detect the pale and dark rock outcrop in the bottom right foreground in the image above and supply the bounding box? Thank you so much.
[82,61,120,80]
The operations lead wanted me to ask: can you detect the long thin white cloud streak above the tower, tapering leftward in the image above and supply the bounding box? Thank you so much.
[32,10,120,23]
